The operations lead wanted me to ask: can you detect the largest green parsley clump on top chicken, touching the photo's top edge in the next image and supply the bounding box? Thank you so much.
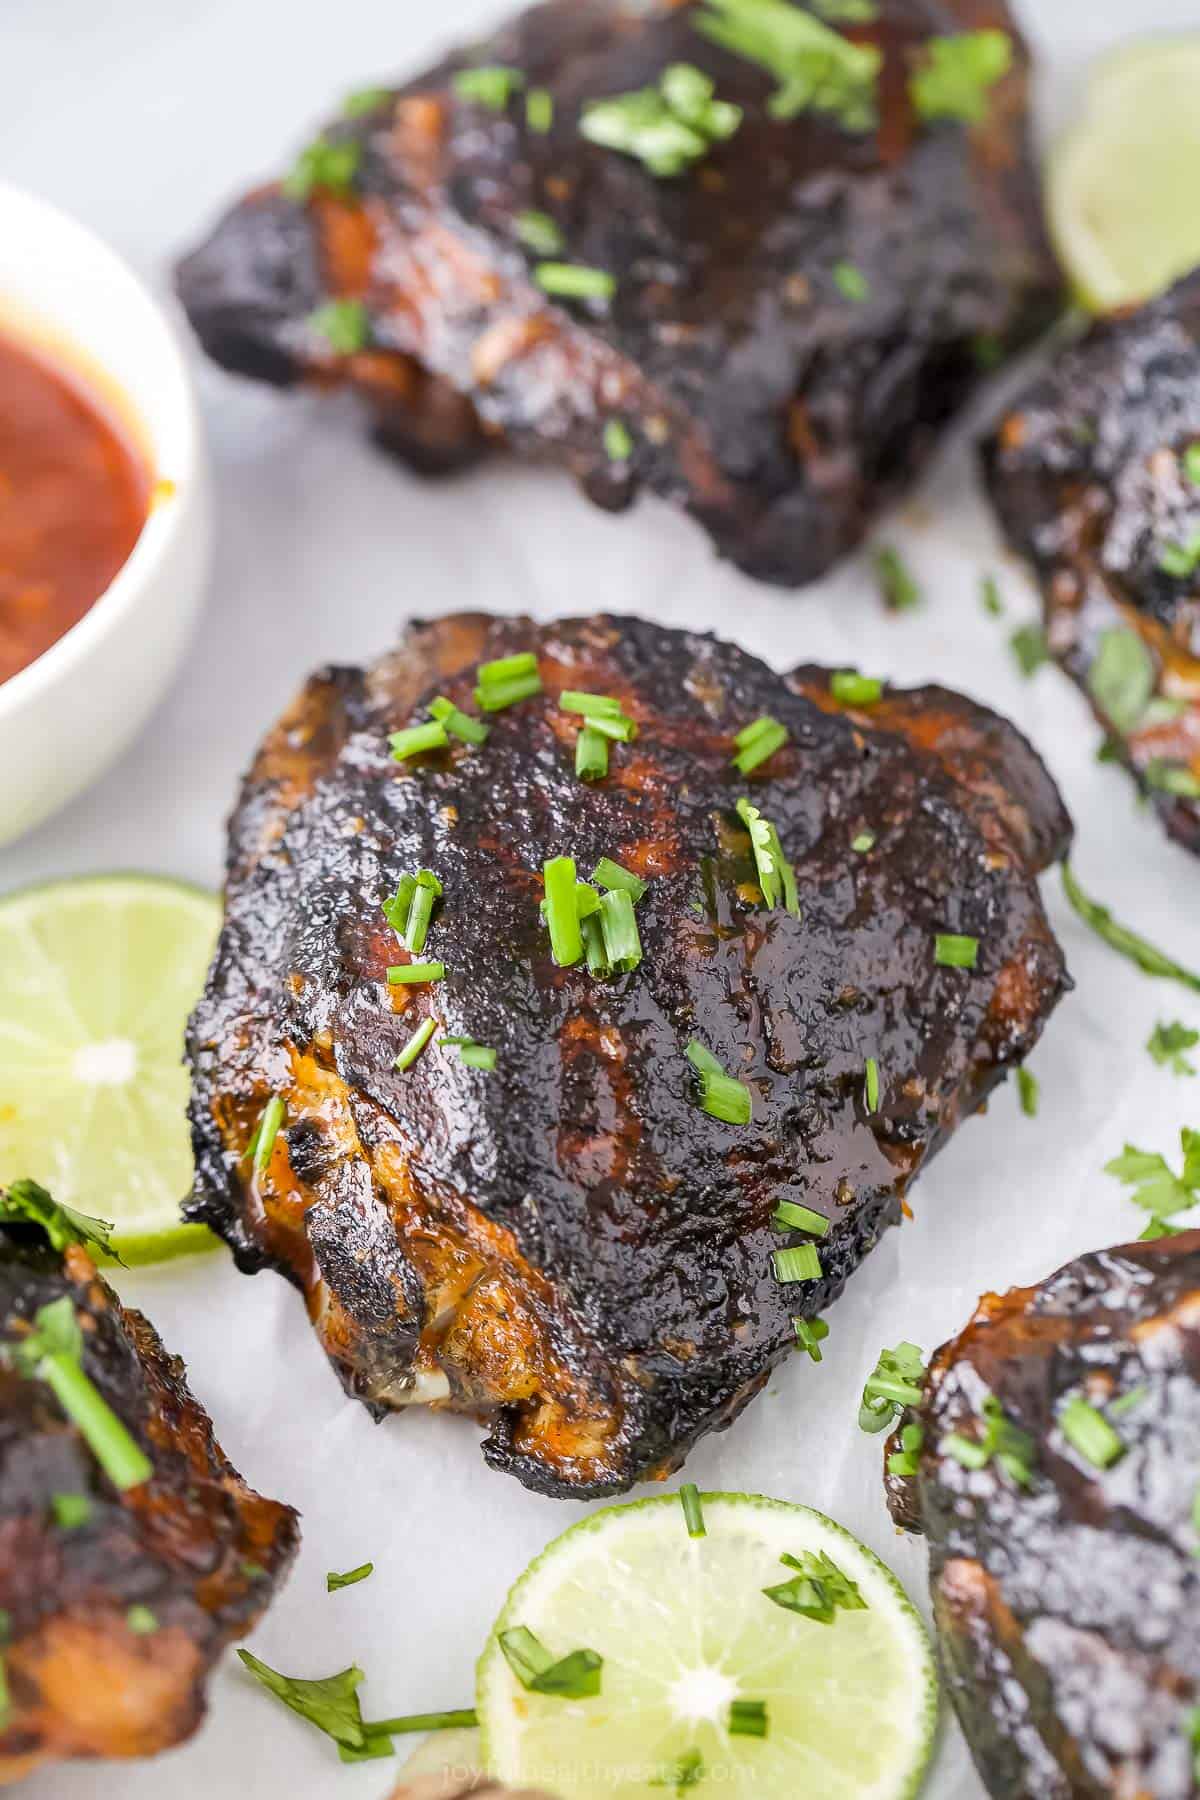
[693,0,883,131]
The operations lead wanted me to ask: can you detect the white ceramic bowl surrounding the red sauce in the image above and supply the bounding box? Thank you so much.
[0,182,210,844]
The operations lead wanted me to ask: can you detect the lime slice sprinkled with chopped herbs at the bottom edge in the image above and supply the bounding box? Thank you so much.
[477,1494,937,1800]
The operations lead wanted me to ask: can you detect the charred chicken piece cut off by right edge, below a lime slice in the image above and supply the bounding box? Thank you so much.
[984,272,1200,853]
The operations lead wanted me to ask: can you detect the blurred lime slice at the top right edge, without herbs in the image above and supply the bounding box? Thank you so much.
[1047,36,1200,313]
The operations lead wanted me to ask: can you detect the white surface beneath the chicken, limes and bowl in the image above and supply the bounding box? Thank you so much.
[0,0,1200,1800]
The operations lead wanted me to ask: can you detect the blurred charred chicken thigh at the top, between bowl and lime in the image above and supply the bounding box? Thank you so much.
[178,0,1060,587]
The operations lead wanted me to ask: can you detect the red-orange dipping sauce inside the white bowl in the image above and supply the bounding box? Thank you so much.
[0,333,153,682]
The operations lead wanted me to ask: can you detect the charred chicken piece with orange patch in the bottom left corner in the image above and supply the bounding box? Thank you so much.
[0,1193,299,1784]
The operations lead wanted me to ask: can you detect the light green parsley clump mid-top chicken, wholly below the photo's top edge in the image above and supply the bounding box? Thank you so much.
[579,63,741,176]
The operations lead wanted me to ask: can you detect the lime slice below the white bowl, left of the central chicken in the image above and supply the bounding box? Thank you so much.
[0,875,219,1262]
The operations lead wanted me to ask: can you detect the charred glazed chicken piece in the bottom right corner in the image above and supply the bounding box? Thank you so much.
[887,1231,1200,1800]
